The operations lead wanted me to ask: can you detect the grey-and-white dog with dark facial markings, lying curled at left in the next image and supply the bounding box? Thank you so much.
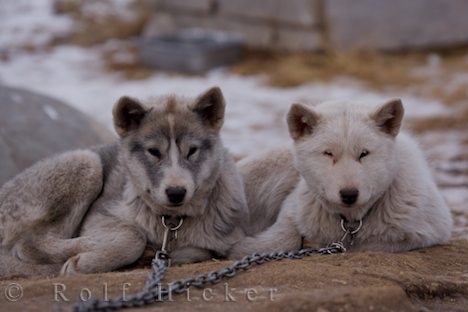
[0,87,247,276]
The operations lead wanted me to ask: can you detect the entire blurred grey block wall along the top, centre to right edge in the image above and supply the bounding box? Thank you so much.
[145,0,468,51]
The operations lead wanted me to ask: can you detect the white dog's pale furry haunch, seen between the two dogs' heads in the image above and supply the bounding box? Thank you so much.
[238,149,300,235]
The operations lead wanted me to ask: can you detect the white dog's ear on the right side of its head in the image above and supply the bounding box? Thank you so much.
[371,99,405,137]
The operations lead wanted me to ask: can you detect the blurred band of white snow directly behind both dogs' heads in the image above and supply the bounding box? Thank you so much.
[0,46,454,155]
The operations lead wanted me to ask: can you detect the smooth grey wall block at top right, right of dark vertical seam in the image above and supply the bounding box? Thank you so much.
[324,0,468,50]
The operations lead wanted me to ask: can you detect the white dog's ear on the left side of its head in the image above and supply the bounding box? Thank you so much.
[287,103,320,140]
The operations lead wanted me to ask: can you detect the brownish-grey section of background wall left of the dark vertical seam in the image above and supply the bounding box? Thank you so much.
[148,0,322,51]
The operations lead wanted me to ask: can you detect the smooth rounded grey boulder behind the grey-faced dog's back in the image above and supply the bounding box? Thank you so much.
[0,86,114,186]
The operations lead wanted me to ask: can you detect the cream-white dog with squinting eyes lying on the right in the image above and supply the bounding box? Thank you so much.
[231,100,452,258]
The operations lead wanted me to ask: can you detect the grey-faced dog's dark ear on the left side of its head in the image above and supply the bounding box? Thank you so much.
[112,96,147,137]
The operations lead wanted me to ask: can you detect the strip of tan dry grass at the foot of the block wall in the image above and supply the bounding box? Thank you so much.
[233,52,425,88]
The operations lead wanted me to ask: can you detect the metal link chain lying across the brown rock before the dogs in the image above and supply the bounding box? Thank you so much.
[63,242,346,312]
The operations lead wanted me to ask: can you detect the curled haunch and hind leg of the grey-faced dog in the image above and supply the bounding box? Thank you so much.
[0,146,103,274]
